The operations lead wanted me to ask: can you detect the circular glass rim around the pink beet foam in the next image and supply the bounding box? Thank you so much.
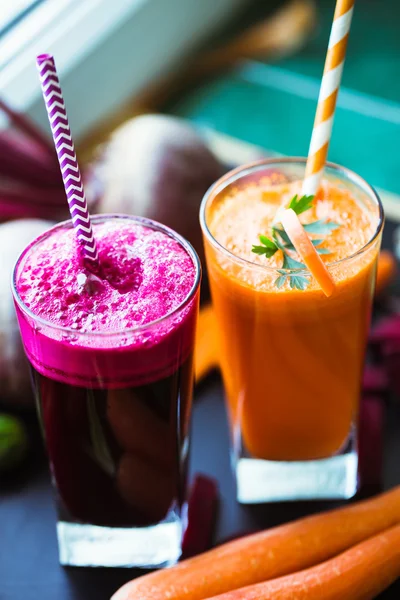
[11,213,202,339]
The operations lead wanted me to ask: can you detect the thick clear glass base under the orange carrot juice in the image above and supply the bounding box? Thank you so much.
[236,451,358,504]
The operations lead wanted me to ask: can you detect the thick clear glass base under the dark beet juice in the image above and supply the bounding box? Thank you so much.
[57,519,182,569]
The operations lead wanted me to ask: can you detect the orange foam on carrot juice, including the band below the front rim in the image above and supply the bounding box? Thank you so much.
[207,176,379,297]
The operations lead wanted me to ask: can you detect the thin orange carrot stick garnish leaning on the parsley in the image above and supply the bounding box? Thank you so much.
[281,208,335,296]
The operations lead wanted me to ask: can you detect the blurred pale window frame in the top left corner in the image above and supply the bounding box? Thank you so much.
[0,0,247,138]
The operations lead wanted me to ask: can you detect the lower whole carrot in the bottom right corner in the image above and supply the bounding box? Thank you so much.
[210,525,400,600]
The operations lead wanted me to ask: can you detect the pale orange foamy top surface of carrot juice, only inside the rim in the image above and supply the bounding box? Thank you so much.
[209,178,378,268]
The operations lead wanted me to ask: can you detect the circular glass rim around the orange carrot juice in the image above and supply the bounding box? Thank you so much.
[200,156,385,275]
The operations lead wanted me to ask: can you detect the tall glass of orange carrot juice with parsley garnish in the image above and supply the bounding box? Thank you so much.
[200,158,383,503]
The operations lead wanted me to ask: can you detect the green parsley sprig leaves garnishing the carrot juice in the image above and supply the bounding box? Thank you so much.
[252,194,340,290]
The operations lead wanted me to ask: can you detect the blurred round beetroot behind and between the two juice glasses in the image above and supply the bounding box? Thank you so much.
[97,115,223,262]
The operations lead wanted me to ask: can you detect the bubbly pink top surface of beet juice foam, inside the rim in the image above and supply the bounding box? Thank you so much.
[17,219,195,333]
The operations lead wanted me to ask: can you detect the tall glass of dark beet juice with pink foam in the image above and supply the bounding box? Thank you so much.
[13,215,200,567]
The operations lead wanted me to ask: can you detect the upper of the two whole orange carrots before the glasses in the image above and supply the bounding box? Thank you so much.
[113,486,400,600]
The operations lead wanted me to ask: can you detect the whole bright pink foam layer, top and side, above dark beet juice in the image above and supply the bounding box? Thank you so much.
[15,217,198,387]
